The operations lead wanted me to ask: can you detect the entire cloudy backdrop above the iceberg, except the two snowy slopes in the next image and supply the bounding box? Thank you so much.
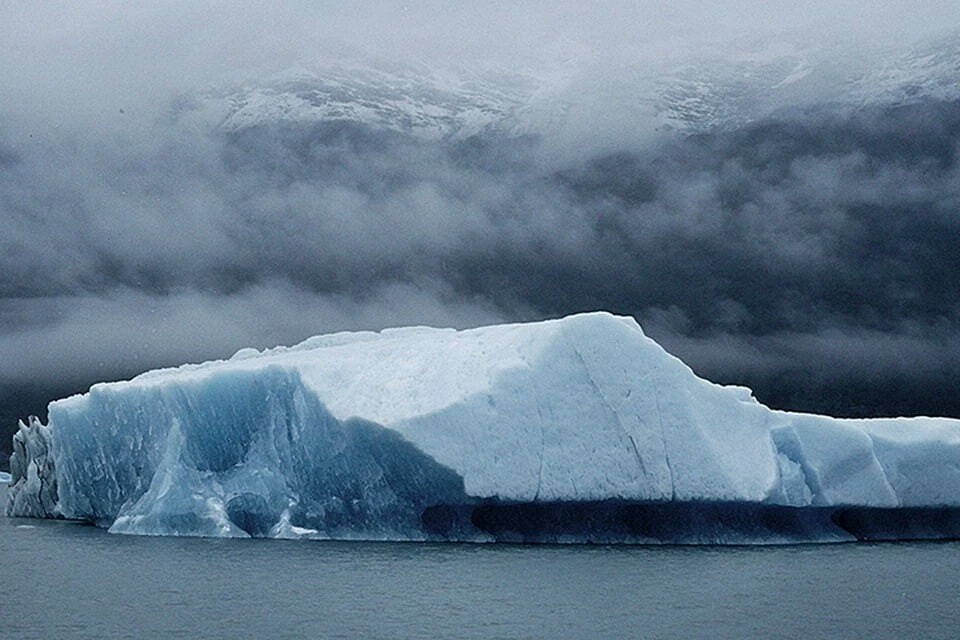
[0,0,960,436]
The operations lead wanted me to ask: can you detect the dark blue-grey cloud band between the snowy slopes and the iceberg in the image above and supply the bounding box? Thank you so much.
[0,95,960,418]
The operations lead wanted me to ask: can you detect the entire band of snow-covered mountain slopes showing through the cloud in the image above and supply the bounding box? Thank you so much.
[175,27,960,140]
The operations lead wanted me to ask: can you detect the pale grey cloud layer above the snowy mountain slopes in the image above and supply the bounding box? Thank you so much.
[0,0,956,130]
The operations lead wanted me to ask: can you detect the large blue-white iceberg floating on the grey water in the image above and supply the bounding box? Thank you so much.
[7,313,960,542]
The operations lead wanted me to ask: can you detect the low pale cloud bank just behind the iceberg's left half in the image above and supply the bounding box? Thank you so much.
[0,282,504,387]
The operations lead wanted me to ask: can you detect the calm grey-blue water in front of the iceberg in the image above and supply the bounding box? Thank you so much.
[0,492,960,640]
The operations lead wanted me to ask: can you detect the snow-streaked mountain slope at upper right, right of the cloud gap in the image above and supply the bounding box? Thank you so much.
[655,32,960,133]
